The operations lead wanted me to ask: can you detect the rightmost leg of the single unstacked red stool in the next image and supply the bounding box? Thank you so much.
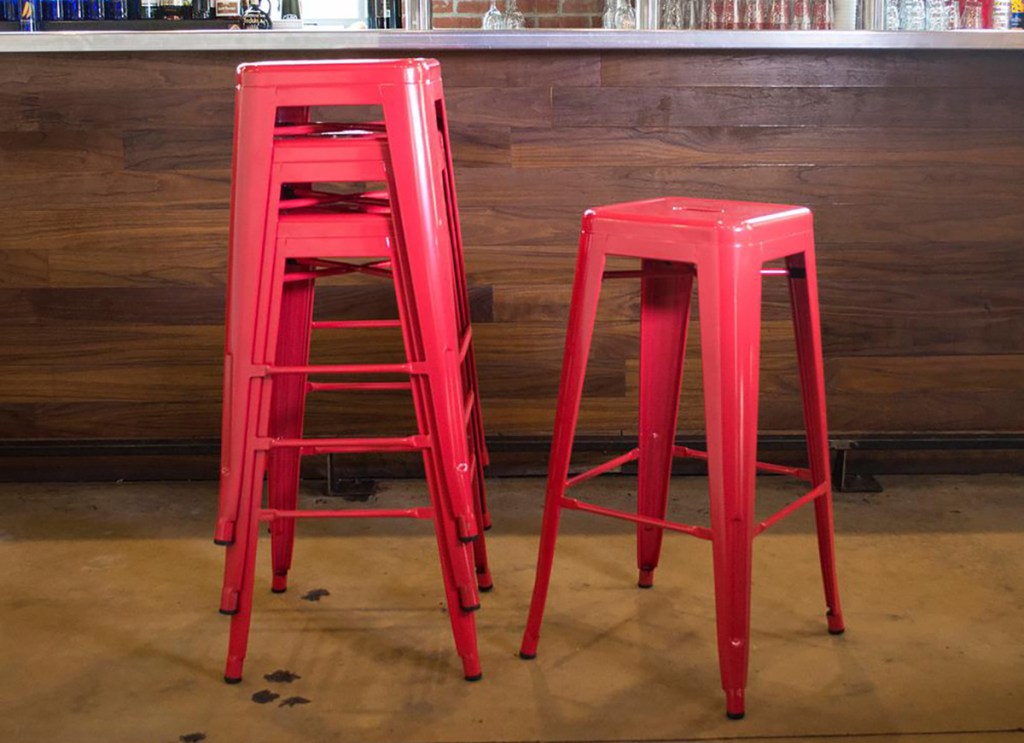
[786,250,845,635]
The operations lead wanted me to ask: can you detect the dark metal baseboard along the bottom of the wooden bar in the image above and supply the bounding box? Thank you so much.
[0,433,1024,492]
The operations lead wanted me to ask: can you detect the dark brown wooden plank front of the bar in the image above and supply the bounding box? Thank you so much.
[0,51,1024,448]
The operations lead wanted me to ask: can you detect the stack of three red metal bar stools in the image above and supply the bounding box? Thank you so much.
[215,59,492,683]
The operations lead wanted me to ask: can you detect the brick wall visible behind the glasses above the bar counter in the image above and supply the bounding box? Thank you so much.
[433,0,604,29]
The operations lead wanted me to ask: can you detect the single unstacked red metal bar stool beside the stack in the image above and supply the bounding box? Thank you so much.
[519,199,844,718]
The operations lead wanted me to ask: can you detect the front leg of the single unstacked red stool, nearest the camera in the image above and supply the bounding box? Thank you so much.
[698,257,761,719]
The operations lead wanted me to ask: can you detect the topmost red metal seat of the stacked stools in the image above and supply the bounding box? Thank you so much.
[237,57,440,87]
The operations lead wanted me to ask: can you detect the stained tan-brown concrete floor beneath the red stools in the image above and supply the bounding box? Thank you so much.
[0,476,1024,743]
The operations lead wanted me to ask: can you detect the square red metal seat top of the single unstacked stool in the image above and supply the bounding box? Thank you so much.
[584,196,811,228]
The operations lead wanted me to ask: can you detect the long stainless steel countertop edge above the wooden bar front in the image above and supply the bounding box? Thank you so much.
[0,29,1024,53]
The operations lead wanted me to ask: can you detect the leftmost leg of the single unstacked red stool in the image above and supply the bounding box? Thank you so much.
[519,232,605,660]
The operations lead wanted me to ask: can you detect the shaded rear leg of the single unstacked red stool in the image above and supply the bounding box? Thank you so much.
[637,260,693,588]
